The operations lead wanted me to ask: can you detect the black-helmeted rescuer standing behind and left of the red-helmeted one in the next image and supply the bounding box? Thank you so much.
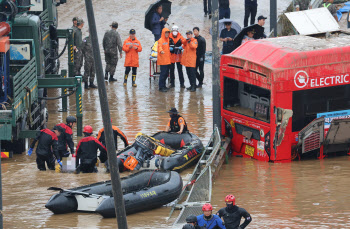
[56,116,77,158]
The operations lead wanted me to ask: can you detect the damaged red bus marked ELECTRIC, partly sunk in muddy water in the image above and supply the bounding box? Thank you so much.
[220,34,350,162]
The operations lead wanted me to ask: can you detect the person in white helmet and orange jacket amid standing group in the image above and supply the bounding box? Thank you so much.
[170,25,185,88]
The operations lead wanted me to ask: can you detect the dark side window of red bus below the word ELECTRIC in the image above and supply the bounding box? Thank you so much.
[292,85,350,132]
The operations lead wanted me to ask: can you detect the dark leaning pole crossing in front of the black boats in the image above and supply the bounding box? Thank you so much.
[85,0,128,229]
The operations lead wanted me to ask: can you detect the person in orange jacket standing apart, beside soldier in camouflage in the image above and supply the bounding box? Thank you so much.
[123,29,142,87]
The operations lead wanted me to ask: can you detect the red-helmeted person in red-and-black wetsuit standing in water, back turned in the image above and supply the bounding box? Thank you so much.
[76,126,107,173]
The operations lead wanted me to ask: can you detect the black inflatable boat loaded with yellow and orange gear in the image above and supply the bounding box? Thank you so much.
[118,132,203,172]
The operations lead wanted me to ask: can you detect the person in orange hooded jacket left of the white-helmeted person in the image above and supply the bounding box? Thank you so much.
[157,28,171,92]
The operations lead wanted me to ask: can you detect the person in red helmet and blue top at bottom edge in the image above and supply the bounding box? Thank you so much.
[197,203,226,229]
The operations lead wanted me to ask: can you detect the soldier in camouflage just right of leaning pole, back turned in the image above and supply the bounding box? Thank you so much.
[103,22,123,81]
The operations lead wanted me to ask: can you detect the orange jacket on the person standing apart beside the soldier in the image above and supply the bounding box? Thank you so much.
[123,37,142,67]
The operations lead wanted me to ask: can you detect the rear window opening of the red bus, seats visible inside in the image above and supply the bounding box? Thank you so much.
[224,77,271,122]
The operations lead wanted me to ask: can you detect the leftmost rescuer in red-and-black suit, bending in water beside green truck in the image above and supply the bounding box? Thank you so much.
[28,127,62,171]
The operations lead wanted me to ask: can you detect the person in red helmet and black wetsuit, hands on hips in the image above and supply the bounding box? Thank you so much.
[217,195,252,229]
